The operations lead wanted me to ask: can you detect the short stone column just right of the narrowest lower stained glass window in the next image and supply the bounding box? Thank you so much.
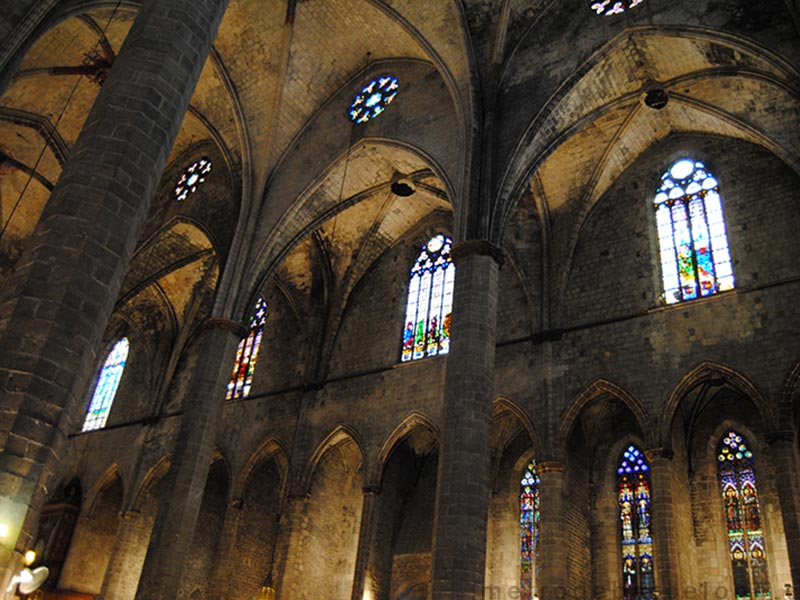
[536,461,570,600]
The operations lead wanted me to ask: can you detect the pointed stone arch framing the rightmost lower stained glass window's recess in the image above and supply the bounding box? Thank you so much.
[657,360,777,448]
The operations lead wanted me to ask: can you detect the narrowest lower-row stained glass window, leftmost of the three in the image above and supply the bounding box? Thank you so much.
[519,460,541,600]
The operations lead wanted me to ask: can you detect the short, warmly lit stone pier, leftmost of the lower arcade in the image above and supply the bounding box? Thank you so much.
[101,510,153,600]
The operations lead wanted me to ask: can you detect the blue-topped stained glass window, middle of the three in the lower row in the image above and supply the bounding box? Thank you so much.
[617,446,655,600]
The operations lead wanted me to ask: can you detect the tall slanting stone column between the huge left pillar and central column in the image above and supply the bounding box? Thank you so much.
[136,319,244,600]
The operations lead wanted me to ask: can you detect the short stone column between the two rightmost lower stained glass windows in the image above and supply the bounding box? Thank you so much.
[645,448,681,600]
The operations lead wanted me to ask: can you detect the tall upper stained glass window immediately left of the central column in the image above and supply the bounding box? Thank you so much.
[402,234,456,362]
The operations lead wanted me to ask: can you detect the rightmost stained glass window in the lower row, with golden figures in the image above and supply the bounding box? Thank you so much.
[717,431,771,598]
